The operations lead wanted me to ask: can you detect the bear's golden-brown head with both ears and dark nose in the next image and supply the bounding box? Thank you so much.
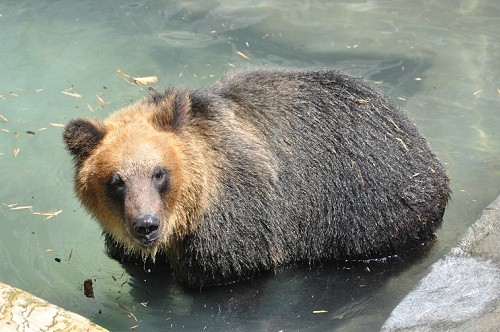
[64,91,210,259]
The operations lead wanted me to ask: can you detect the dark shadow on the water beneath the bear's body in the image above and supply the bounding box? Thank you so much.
[117,241,433,331]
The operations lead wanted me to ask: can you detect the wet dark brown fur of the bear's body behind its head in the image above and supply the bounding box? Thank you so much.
[65,70,450,287]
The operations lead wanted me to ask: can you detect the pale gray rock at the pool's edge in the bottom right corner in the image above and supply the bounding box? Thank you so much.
[382,197,500,331]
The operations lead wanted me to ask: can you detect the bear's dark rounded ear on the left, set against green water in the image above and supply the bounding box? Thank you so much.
[63,119,105,162]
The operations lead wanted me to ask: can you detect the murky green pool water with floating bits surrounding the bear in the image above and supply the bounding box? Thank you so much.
[0,0,500,331]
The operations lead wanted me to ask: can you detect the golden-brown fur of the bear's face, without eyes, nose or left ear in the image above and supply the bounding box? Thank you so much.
[71,101,215,259]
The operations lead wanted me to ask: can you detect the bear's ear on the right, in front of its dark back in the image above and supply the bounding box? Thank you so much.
[151,90,191,130]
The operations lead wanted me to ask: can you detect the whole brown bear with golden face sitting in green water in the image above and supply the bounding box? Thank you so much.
[64,69,450,287]
